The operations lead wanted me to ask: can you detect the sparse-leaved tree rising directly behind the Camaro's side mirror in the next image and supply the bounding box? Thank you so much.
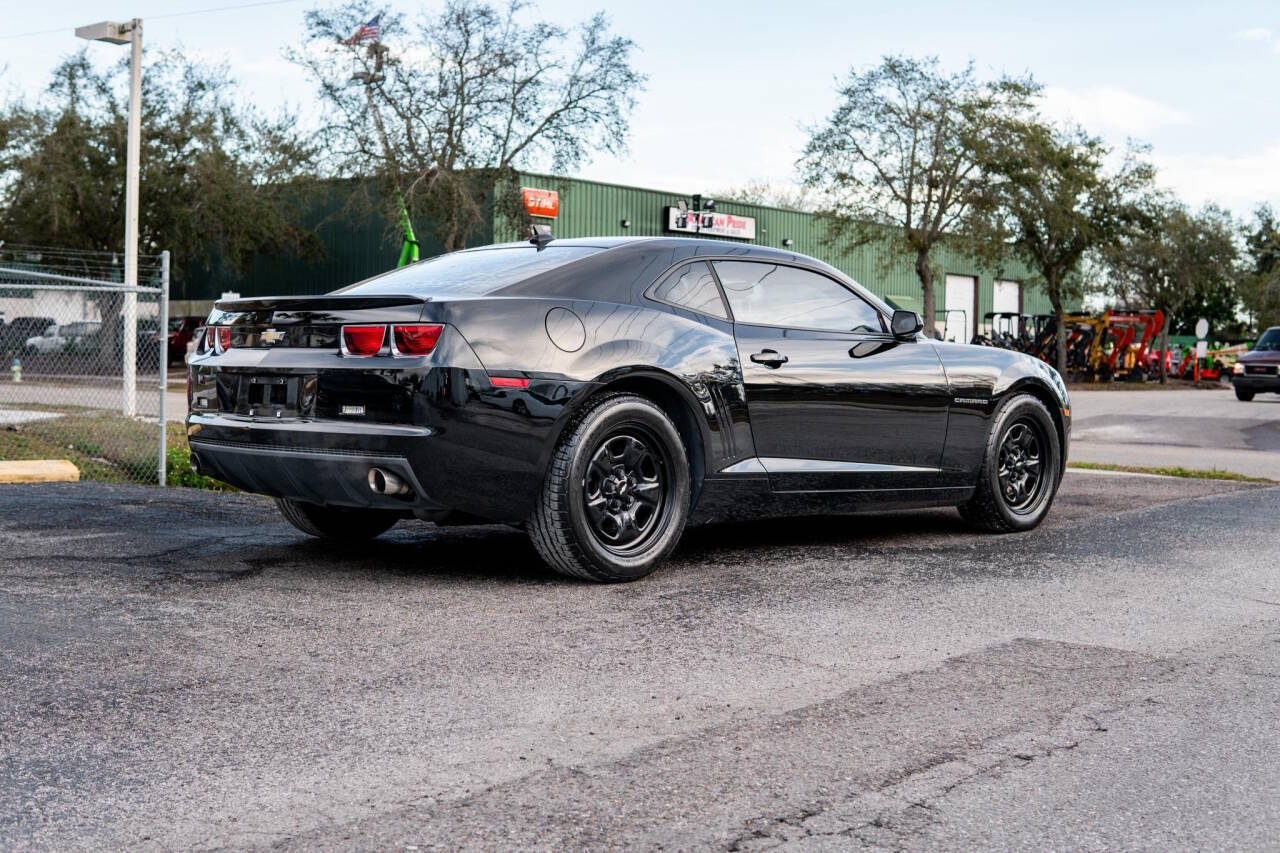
[800,56,1037,334]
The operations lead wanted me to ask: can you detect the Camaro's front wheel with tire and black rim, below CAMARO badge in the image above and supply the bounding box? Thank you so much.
[959,394,1062,533]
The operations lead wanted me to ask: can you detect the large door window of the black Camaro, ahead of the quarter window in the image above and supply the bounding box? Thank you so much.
[714,261,884,334]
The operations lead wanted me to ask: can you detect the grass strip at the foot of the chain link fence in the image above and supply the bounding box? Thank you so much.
[0,403,236,492]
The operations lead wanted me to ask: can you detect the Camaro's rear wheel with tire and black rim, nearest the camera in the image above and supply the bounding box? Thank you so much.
[527,393,691,583]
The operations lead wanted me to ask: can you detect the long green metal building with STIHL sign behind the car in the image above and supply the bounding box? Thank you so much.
[183,173,1050,339]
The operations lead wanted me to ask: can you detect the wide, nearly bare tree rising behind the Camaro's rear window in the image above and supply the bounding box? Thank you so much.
[291,0,644,251]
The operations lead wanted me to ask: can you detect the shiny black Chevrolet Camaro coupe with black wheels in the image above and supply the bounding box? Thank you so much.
[187,237,1070,580]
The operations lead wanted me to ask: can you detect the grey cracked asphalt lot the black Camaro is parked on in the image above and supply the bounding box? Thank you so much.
[0,473,1280,849]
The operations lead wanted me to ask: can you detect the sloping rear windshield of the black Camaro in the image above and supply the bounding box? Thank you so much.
[334,246,602,296]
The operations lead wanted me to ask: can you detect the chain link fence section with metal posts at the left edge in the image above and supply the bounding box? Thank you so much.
[0,246,171,484]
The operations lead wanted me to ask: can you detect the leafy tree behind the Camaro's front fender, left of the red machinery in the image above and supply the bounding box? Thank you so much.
[988,119,1155,375]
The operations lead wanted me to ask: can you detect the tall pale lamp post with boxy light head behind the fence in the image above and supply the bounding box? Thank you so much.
[76,18,144,418]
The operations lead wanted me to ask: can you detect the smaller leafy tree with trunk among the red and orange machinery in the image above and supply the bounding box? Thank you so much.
[1107,196,1238,383]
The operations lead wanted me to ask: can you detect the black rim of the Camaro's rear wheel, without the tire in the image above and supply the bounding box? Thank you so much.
[582,424,671,556]
